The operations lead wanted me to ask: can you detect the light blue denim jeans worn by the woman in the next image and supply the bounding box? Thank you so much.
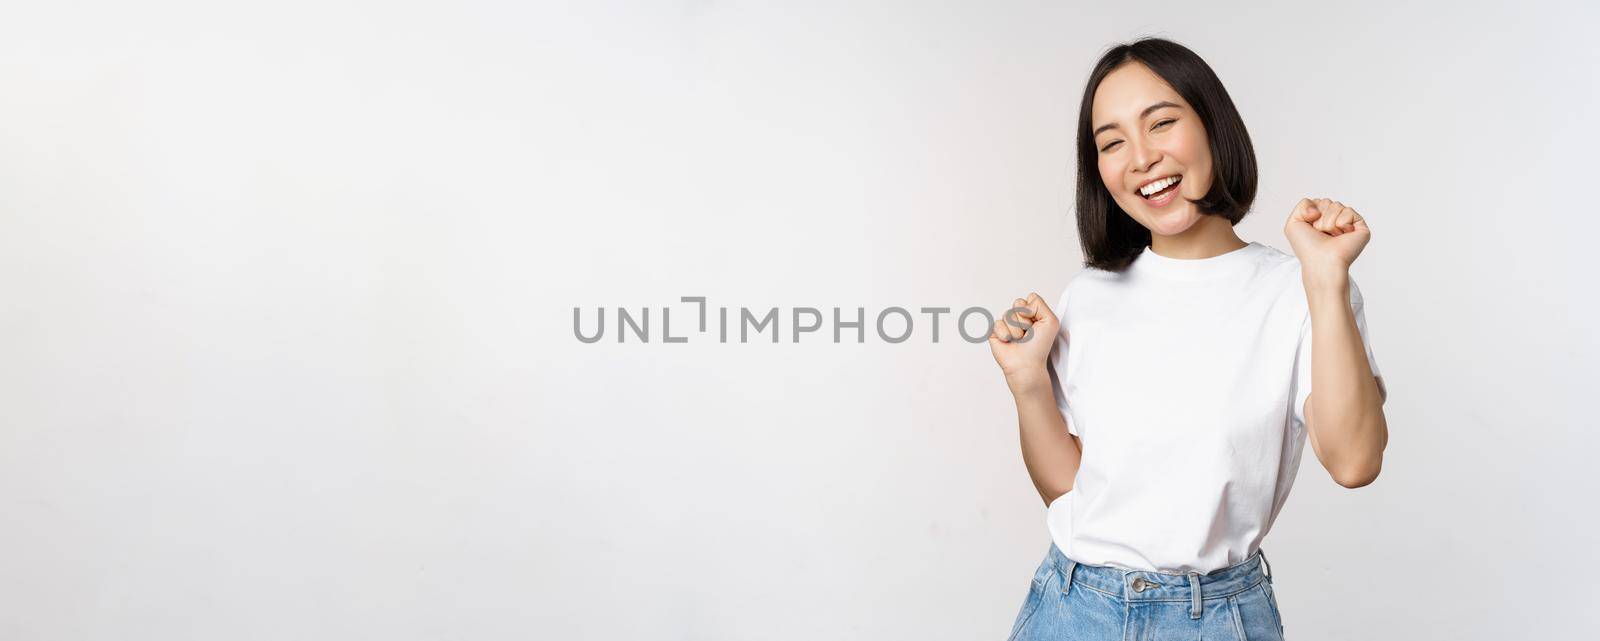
[1010,543,1283,641]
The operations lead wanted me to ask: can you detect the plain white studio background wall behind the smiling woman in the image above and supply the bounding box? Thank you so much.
[0,2,1600,639]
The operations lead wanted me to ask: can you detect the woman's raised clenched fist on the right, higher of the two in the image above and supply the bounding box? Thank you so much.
[1283,198,1373,280]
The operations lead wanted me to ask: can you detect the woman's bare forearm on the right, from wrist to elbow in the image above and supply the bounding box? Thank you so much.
[1304,273,1389,488]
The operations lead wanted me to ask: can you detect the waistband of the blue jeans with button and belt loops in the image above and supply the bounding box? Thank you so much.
[1050,543,1272,615]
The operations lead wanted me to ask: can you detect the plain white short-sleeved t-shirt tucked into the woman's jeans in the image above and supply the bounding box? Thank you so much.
[1046,236,1387,574]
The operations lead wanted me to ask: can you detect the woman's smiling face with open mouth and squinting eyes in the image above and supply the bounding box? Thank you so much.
[1091,62,1211,235]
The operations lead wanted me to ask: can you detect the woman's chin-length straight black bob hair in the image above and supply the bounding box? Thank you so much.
[1077,38,1256,272]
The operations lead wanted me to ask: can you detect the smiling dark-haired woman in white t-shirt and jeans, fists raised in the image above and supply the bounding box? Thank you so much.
[989,38,1389,641]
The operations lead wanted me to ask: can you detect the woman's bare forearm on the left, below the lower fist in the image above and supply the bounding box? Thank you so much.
[1011,374,1083,505]
